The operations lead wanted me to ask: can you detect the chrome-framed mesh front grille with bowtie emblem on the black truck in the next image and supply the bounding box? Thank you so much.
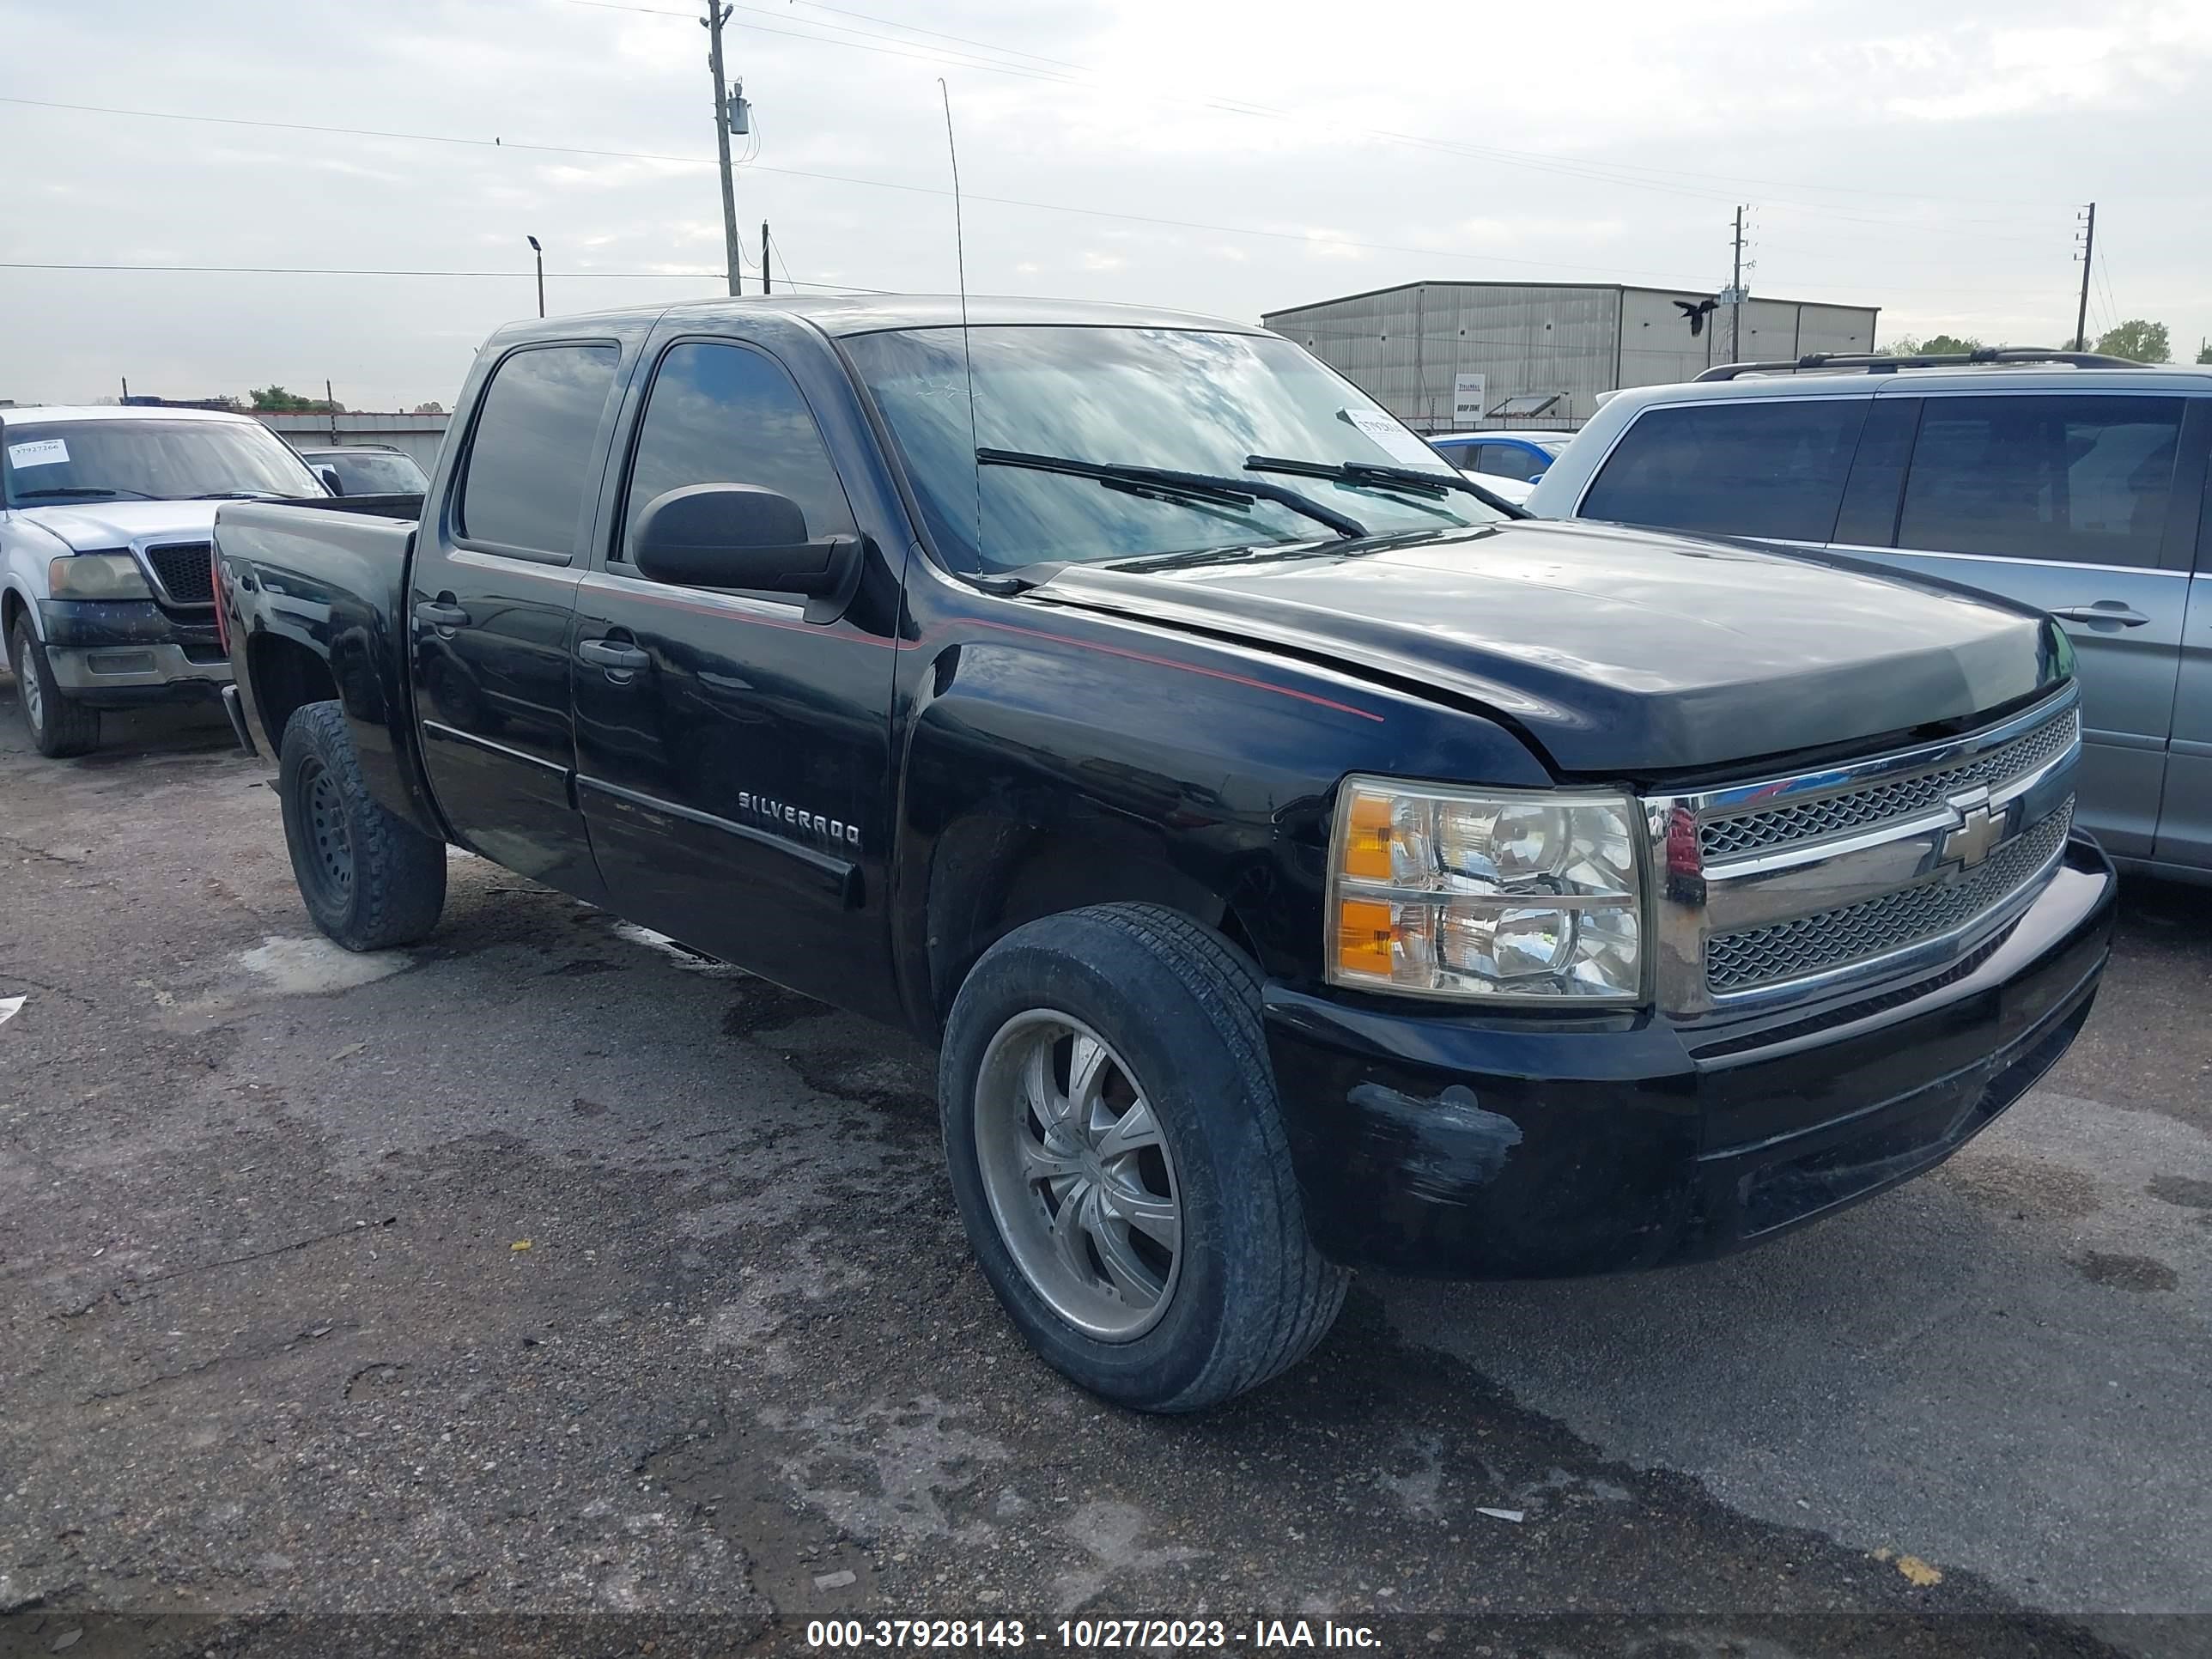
[1644,686,2081,1018]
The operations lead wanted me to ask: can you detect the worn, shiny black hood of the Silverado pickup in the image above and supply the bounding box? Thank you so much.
[1030,520,2066,776]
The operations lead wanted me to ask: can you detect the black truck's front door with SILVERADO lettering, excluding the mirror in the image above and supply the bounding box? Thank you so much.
[573,338,898,1018]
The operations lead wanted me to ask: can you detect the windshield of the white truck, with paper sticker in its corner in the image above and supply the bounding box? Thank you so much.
[0,420,325,507]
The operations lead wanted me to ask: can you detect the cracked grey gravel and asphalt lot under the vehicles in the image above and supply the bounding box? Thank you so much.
[0,677,2212,1659]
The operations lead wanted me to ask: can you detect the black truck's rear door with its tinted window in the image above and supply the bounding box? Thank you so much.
[410,341,622,900]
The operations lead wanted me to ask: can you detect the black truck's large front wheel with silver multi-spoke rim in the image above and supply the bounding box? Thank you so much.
[938,905,1352,1411]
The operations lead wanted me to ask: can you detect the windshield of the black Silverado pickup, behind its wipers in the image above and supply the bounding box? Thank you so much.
[845,327,1502,571]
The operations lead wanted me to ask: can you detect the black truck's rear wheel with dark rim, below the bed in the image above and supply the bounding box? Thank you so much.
[276,703,445,951]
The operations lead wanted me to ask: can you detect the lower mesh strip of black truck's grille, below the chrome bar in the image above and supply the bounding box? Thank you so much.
[1705,799,2073,995]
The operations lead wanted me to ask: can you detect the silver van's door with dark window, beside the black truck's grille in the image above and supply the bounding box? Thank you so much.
[1836,389,2212,858]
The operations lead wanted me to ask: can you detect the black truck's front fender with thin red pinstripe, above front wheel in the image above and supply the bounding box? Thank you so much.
[894,606,1551,1029]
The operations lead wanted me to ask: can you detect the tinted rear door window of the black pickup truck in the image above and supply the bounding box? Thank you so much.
[456,345,622,553]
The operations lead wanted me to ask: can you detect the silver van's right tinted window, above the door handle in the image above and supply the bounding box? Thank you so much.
[1898,394,2181,566]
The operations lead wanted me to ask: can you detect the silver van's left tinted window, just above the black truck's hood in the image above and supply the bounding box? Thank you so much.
[1579,398,1869,542]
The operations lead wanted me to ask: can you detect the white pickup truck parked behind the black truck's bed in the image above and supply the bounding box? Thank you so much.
[0,404,330,757]
